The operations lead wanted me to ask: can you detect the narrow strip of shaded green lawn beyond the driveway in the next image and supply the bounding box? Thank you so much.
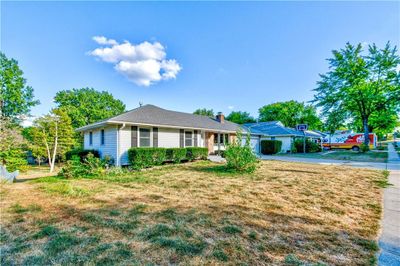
[276,150,388,163]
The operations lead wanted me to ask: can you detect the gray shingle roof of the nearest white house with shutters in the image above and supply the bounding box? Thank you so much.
[78,104,239,132]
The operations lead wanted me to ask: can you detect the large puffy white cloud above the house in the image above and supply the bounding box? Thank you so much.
[89,36,182,87]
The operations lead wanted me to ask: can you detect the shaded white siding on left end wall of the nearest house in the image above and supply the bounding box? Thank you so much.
[83,126,117,160]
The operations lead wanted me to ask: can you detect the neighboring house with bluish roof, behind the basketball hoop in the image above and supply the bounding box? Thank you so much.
[242,121,323,153]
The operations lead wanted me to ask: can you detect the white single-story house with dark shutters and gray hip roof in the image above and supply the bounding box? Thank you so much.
[77,105,240,165]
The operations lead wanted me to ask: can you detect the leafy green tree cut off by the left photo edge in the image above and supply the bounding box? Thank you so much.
[0,52,39,123]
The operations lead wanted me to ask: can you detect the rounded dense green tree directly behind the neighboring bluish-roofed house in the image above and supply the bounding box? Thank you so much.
[258,100,322,129]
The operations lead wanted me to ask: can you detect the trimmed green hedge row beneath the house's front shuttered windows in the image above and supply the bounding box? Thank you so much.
[128,147,208,169]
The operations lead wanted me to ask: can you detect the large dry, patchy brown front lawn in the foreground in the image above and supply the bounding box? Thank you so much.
[0,161,387,265]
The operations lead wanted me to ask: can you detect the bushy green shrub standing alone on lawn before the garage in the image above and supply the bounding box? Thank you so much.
[225,132,258,173]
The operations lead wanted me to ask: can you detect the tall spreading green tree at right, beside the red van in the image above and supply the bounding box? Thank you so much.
[314,43,400,145]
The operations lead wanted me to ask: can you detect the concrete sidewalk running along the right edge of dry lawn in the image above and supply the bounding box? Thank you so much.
[379,144,400,266]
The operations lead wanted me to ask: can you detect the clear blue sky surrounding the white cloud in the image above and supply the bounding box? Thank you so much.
[1,1,400,119]
